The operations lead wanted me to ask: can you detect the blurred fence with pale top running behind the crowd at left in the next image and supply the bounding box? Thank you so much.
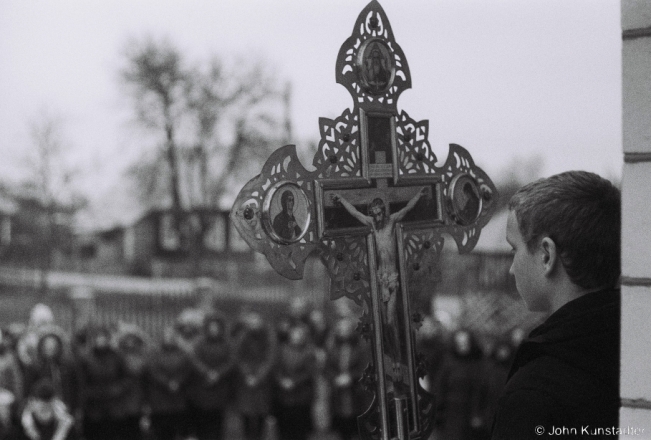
[0,268,290,337]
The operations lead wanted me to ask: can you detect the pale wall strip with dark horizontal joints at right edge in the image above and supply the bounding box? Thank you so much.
[620,0,651,430]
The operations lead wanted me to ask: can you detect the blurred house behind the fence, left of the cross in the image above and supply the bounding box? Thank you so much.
[78,209,255,280]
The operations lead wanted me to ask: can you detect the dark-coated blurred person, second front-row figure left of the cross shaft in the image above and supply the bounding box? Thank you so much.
[274,323,316,440]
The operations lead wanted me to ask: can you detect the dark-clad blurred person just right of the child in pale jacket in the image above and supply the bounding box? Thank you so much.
[79,327,130,440]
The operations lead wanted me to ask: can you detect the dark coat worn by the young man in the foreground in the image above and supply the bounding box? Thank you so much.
[492,290,621,440]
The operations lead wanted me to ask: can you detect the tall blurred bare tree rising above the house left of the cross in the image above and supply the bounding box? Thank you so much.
[120,39,288,276]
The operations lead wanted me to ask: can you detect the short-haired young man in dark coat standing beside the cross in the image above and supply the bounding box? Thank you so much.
[492,171,621,440]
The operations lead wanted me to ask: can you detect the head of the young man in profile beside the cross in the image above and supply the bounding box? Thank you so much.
[507,171,621,311]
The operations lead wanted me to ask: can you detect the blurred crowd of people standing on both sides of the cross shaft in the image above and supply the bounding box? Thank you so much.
[0,301,514,440]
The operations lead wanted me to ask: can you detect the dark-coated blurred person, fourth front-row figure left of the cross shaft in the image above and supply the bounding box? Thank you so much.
[188,311,234,440]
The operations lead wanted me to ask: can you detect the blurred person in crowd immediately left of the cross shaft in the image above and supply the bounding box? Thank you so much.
[325,318,370,440]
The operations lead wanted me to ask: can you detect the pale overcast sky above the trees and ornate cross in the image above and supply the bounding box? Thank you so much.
[0,0,622,227]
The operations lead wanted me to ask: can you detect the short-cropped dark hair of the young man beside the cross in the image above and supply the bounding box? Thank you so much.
[509,171,621,289]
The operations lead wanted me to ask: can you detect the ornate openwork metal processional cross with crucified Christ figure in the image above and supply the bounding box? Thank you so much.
[231,0,497,440]
